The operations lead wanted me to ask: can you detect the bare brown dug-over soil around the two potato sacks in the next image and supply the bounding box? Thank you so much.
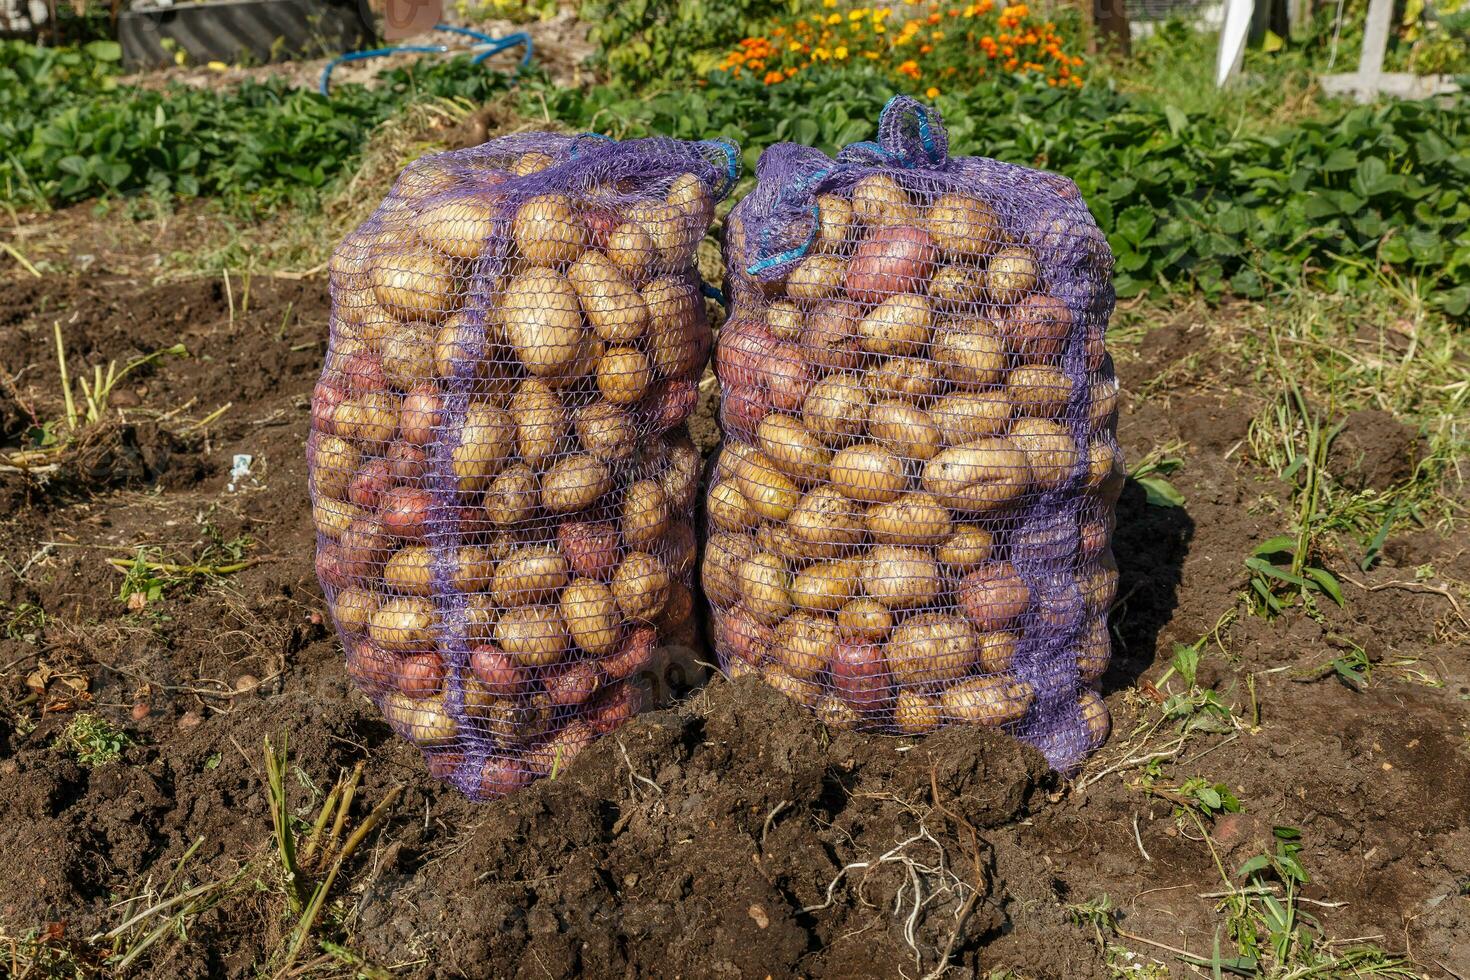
[0,257,1470,979]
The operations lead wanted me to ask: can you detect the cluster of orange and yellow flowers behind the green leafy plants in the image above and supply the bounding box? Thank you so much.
[720,0,1083,89]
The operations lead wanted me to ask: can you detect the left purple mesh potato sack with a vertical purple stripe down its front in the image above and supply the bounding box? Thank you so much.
[307,134,738,799]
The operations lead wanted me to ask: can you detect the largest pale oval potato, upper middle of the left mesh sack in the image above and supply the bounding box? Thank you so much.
[500,267,588,385]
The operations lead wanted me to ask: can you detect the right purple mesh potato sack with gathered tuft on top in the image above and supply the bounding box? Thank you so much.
[703,97,1122,770]
